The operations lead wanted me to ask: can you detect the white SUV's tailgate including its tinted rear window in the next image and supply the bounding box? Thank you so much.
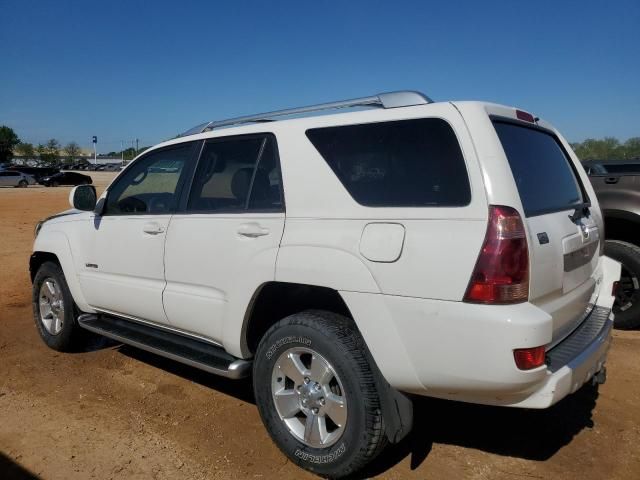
[493,122,600,343]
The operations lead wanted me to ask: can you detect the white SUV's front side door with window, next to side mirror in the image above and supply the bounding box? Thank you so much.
[80,142,200,323]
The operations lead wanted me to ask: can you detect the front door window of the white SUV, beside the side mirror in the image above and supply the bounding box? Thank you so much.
[105,142,193,215]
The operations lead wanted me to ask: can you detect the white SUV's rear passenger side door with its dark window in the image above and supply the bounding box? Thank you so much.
[163,134,284,344]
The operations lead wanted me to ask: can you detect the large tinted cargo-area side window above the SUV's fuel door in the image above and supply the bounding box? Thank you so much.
[307,118,471,207]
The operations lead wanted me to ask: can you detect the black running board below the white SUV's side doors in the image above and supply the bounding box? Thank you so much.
[78,314,251,379]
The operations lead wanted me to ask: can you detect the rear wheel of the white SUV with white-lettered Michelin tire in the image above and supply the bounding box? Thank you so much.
[253,311,386,478]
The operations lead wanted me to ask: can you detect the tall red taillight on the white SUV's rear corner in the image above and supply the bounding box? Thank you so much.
[464,205,529,304]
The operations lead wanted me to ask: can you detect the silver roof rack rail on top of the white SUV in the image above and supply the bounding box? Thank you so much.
[179,90,433,137]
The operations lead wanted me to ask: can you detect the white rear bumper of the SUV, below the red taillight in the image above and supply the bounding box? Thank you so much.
[341,257,620,408]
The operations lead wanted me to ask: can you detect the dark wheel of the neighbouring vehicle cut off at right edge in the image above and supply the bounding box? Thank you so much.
[604,240,640,330]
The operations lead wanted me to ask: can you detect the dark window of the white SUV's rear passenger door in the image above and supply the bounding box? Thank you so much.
[187,135,283,212]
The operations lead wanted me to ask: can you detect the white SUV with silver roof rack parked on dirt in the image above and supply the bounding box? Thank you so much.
[30,92,620,477]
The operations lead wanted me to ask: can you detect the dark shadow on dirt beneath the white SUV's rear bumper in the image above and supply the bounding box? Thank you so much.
[357,384,598,478]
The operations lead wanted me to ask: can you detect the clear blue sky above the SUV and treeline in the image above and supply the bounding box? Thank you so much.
[0,0,640,152]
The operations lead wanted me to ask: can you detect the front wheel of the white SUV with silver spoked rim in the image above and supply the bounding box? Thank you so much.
[32,262,81,351]
